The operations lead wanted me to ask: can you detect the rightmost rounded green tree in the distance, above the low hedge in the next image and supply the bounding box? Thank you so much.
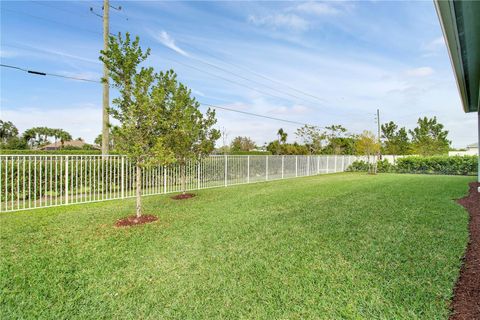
[409,117,451,156]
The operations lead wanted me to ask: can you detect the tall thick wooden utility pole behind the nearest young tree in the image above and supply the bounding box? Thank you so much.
[102,0,110,155]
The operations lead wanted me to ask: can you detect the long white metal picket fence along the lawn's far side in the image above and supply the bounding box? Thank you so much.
[0,155,365,212]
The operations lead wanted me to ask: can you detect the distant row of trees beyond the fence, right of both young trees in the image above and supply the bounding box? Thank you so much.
[218,117,451,156]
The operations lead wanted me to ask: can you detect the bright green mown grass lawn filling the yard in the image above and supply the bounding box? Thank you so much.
[0,174,474,319]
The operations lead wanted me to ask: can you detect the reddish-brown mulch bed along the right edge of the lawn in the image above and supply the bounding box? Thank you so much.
[450,182,480,320]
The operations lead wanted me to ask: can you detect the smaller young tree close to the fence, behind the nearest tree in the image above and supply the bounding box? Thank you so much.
[165,76,220,194]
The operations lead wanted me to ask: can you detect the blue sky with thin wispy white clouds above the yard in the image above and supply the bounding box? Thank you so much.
[0,1,476,147]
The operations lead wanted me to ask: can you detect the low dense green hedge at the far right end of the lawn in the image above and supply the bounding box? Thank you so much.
[347,156,478,176]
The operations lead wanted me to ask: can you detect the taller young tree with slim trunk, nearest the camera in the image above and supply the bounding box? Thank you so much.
[100,33,175,218]
